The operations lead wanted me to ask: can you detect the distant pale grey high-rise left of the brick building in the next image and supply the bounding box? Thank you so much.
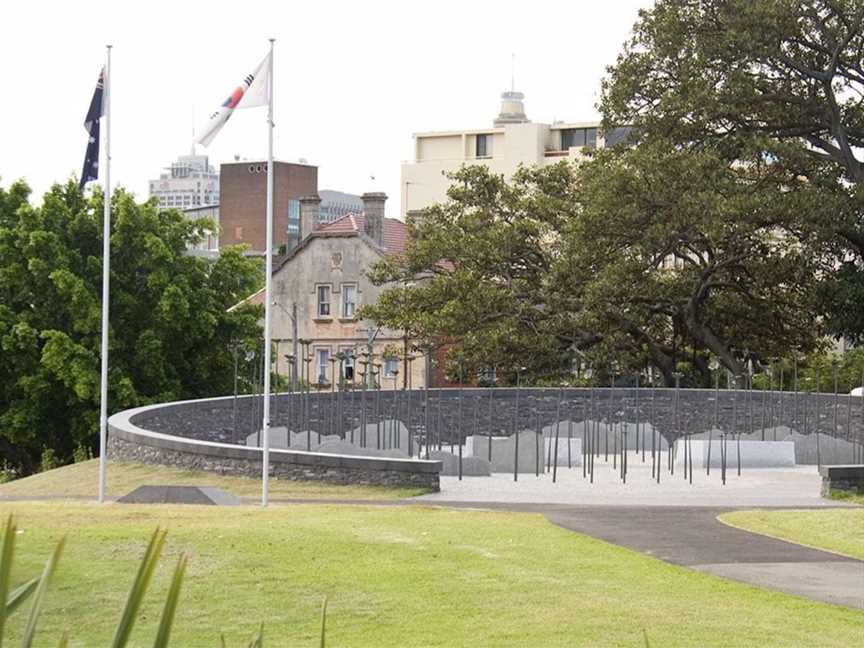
[150,155,219,209]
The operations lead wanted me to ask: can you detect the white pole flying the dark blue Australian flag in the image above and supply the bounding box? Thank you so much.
[99,45,111,503]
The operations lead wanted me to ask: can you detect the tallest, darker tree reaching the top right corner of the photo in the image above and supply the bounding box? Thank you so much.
[601,0,864,341]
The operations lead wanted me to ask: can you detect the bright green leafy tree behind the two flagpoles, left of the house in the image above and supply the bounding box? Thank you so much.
[0,182,262,471]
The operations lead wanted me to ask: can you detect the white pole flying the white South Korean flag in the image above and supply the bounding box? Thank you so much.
[261,38,276,506]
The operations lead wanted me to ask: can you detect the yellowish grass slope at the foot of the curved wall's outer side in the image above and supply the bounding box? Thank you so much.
[0,459,426,499]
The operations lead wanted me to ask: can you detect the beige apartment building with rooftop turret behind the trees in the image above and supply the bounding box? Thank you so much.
[401,90,629,218]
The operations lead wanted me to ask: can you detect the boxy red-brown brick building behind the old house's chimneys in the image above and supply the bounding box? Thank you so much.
[219,160,318,253]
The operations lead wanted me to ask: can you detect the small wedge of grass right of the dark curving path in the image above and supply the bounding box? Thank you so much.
[720,508,864,560]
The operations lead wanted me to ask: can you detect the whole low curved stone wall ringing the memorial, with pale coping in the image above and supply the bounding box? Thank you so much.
[109,387,864,488]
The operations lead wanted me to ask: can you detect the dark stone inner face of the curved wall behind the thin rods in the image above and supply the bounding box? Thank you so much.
[136,388,864,463]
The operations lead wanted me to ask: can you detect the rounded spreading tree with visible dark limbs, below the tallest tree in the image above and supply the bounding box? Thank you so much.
[552,139,825,383]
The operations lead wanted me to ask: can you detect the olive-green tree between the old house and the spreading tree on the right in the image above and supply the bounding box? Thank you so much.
[361,164,581,376]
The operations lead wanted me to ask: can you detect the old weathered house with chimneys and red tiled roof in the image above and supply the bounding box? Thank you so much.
[251,193,426,389]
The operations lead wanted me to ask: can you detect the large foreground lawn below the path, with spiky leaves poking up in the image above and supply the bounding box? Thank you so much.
[0,502,864,648]
